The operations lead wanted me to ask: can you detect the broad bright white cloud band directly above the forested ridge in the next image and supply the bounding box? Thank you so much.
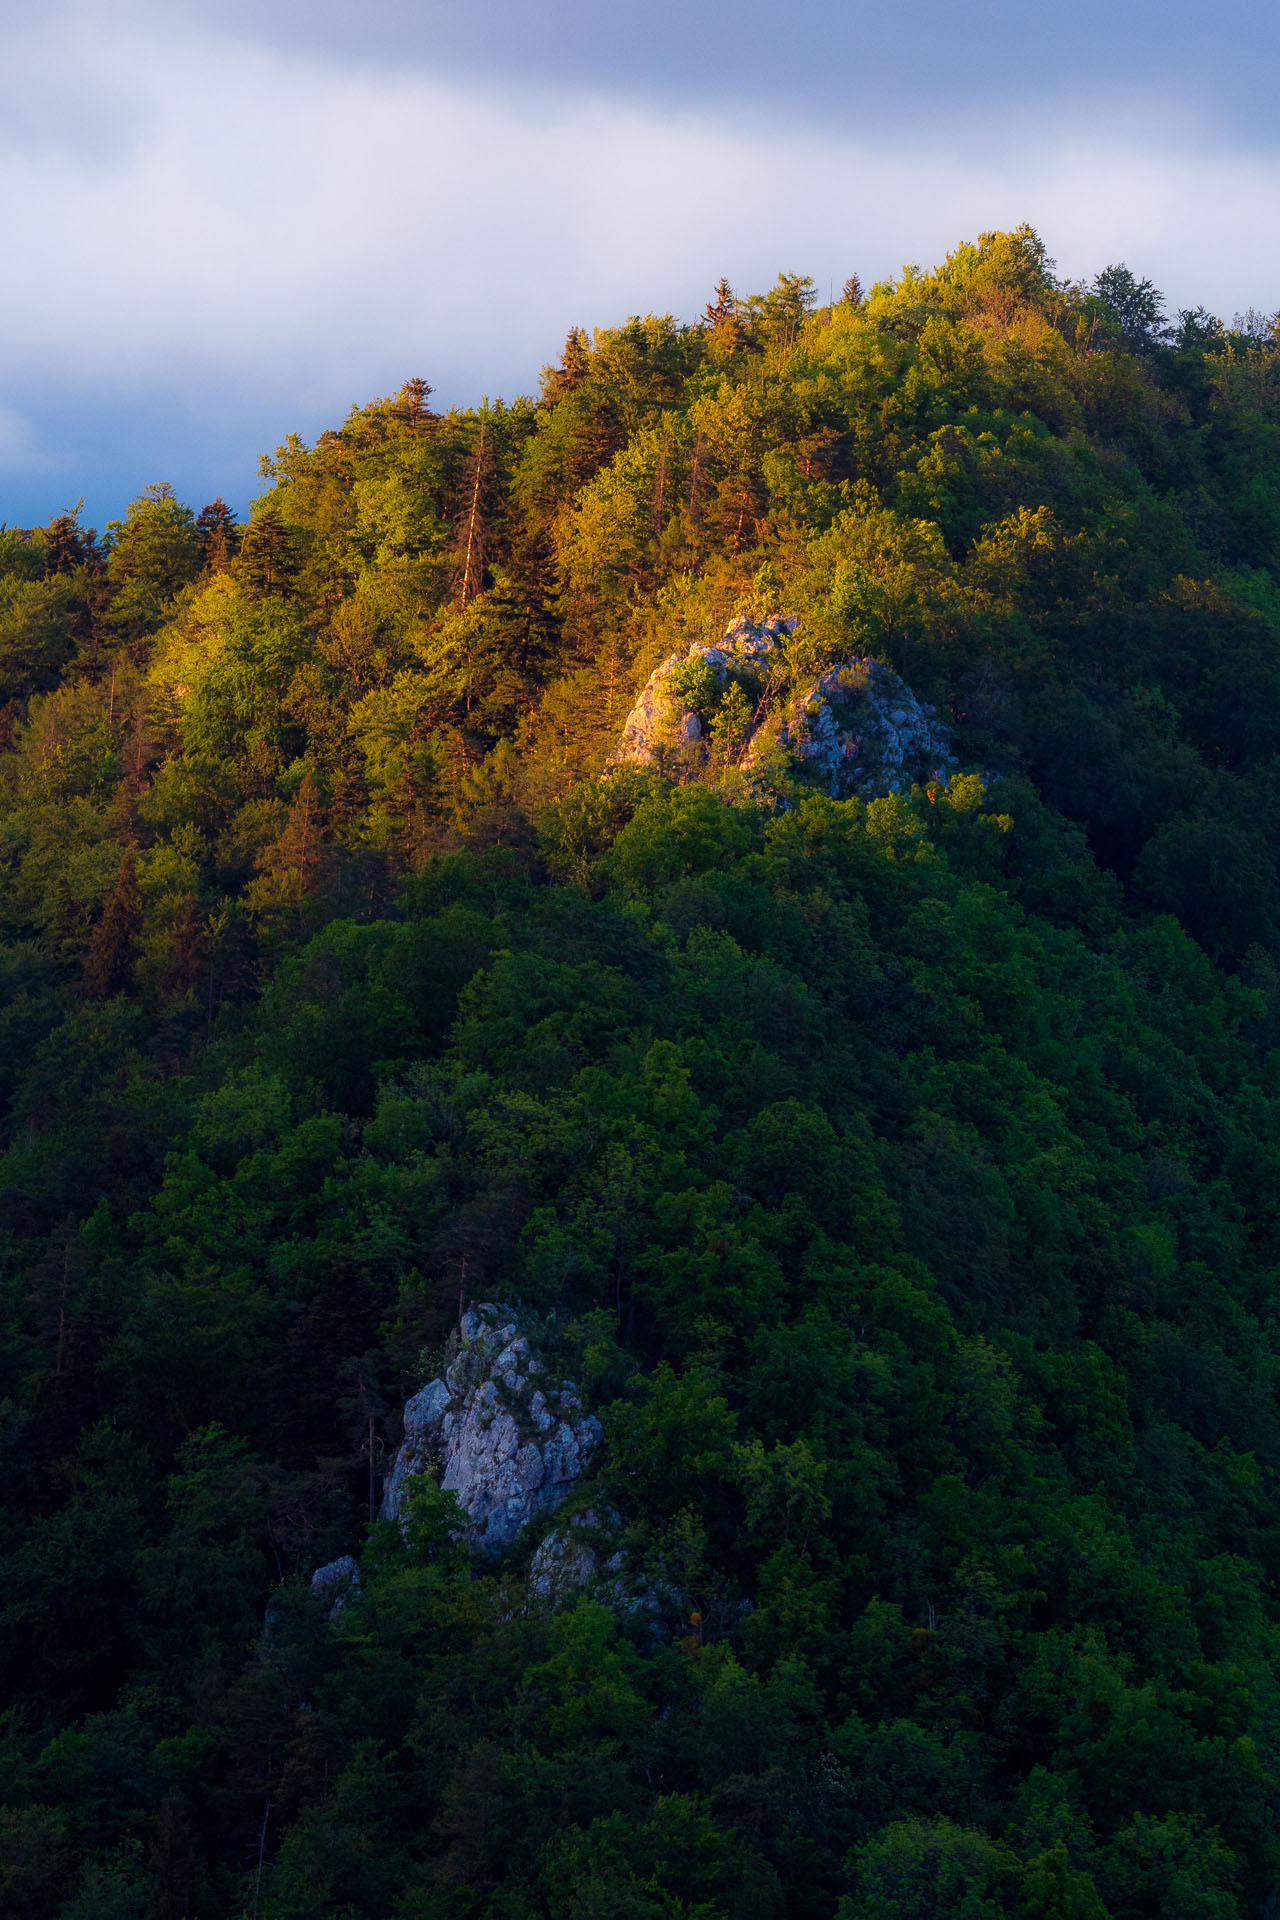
[0,25,1280,522]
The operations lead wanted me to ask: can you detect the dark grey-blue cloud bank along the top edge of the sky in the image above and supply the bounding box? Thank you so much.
[105,0,1280,142]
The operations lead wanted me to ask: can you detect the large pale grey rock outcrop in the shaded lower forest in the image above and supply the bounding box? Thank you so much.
[382,1306,601,1553]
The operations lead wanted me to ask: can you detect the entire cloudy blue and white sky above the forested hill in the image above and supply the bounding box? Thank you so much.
[0,0,1280,526]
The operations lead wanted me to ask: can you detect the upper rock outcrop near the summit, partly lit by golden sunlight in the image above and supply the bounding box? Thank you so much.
[614,614,956,799]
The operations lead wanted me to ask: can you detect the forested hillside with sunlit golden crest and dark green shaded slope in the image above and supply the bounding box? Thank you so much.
[0,228,1280,1920]
